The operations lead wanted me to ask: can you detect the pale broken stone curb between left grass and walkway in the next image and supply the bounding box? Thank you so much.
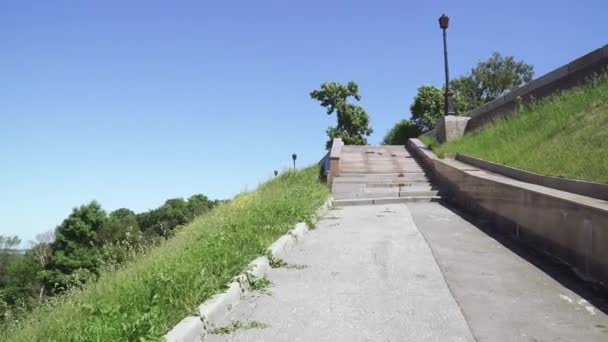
[164,198,333,342]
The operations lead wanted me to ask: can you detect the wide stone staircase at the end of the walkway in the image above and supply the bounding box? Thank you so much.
[332,145,440,206]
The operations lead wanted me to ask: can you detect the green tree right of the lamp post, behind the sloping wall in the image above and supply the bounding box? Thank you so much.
[450,52,534,111]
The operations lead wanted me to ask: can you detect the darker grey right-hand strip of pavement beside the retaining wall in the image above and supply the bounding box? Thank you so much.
[408,203,608,341]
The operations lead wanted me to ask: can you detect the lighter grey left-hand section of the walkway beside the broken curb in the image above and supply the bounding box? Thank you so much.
[208,204,473,341]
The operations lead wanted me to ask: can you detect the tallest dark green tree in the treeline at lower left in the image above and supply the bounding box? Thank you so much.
[44,201,107,291]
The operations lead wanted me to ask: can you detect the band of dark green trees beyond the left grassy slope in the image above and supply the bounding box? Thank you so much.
[0,194,224,323]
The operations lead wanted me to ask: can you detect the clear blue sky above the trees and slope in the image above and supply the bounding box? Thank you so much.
[0,0,608,241]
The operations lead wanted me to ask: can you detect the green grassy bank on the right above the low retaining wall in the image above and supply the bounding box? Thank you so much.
[432,81,608,183]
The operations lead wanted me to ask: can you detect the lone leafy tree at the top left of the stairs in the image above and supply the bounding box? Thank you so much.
[310,81,373,150]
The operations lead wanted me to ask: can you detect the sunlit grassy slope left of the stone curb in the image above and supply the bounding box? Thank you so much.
[0,167,328,341]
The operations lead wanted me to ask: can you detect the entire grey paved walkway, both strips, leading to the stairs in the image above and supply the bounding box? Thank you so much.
[206,203,608,341]
